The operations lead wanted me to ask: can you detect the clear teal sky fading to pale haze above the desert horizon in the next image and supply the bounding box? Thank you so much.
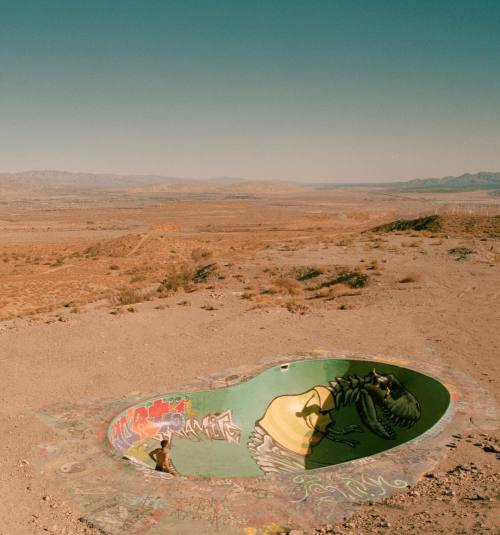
[0,0,500,182]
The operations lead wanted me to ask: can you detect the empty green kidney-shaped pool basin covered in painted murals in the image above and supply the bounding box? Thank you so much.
[108,359,450,477]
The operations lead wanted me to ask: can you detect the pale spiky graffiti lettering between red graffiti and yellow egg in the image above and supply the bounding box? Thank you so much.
[172,410,241,444]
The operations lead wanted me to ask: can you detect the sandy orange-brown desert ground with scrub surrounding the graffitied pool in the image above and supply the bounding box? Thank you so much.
[0,183,500,535]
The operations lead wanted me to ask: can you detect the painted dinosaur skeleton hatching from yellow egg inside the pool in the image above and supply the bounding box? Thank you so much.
[248,370,421,472]
